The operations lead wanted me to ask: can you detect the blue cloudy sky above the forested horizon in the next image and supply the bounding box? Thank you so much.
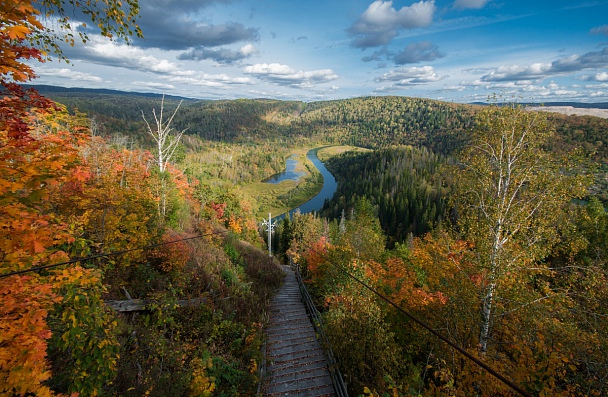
[34,0,608,103]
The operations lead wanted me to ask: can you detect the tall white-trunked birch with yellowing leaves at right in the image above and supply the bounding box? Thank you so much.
[453,105,585,354]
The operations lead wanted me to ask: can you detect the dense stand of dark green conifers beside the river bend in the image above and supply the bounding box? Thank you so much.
[322,146,448,244]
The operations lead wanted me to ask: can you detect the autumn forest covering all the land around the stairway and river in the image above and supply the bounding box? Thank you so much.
[0,0,608,397]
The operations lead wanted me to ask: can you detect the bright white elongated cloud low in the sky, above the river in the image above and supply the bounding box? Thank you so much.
[243,63,338,88]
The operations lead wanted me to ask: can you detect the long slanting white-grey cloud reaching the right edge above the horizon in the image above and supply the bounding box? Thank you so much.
[481,47,608,81]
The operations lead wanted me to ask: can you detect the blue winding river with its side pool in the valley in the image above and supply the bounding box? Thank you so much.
[265,148,338,221]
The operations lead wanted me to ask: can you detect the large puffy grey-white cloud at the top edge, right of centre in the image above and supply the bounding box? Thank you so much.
[348,0,436,48]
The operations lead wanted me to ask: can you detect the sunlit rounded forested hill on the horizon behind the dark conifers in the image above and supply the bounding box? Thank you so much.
[293,97,475,153]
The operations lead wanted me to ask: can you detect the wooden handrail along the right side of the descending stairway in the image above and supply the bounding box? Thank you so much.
[290,261,348,397]
